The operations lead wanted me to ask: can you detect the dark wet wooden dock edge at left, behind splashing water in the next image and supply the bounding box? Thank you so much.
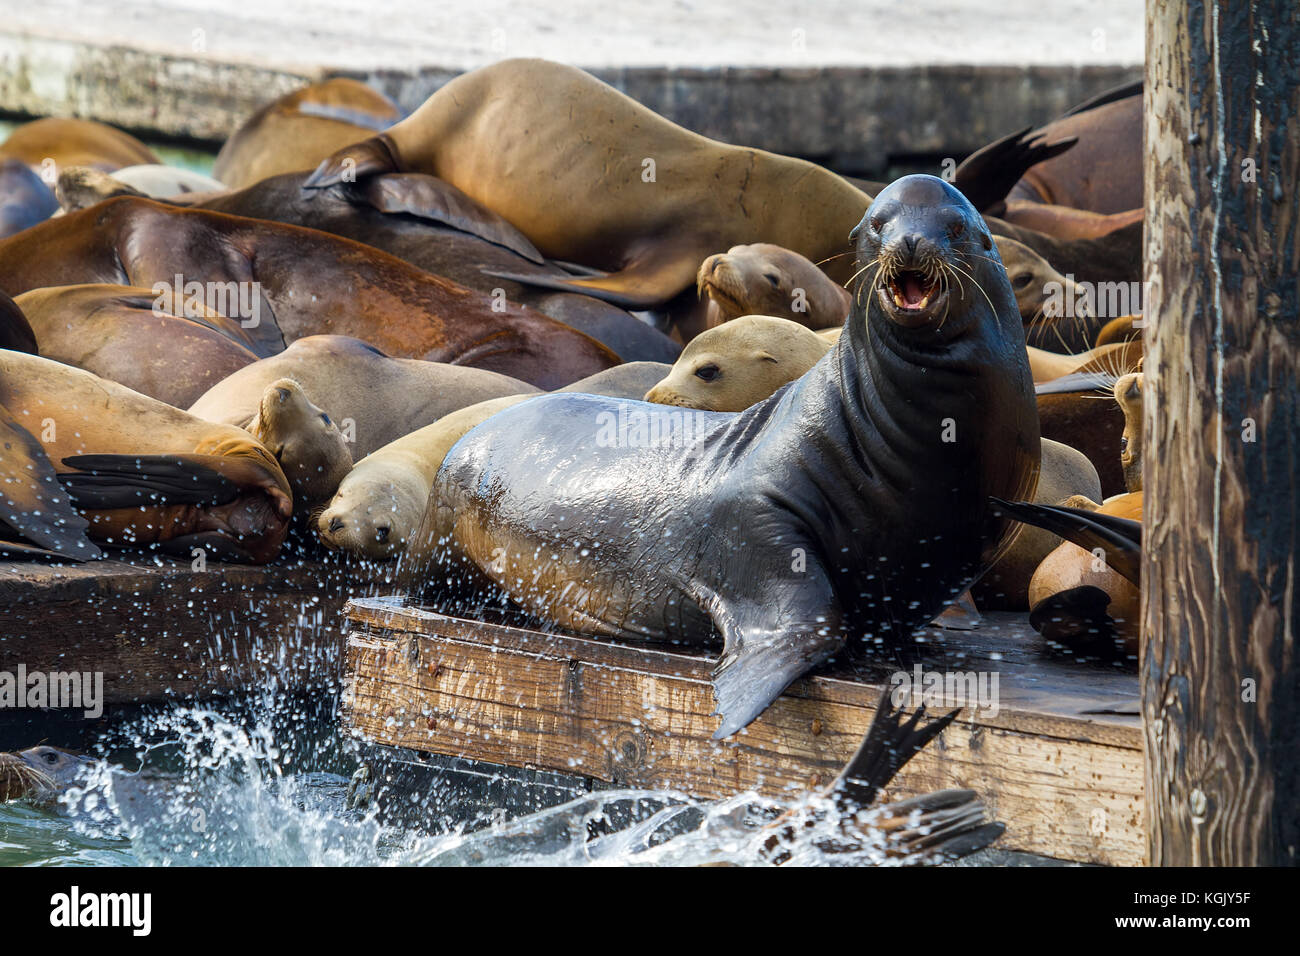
[0,555,376,706]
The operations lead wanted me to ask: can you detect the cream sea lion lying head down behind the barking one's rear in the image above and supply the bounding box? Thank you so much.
[315,362,668,561]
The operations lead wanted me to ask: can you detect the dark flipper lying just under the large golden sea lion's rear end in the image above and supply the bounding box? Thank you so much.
[352,173,546,264]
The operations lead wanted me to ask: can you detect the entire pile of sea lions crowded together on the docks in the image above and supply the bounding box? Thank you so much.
[0,60,1141,737]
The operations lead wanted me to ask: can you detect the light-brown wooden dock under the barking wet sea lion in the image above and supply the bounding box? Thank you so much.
[343,598,1145,865]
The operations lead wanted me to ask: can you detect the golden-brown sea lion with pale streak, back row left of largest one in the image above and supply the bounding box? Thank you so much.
[212,77,403,189]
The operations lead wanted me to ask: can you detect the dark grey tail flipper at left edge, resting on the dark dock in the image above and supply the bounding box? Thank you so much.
[0,406,104,561]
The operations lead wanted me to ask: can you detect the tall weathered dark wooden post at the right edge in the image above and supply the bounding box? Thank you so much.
[1141,0,1300,865]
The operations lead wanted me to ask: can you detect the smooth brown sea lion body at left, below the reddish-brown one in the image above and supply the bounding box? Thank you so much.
[17,284,257,408]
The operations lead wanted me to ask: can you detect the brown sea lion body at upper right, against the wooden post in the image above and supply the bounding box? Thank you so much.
[1008,83,1143,215]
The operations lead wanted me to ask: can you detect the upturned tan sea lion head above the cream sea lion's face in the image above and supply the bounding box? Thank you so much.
[246,378,352,505]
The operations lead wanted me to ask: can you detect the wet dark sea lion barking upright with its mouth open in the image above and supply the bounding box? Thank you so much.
[402,176,1039,739]
